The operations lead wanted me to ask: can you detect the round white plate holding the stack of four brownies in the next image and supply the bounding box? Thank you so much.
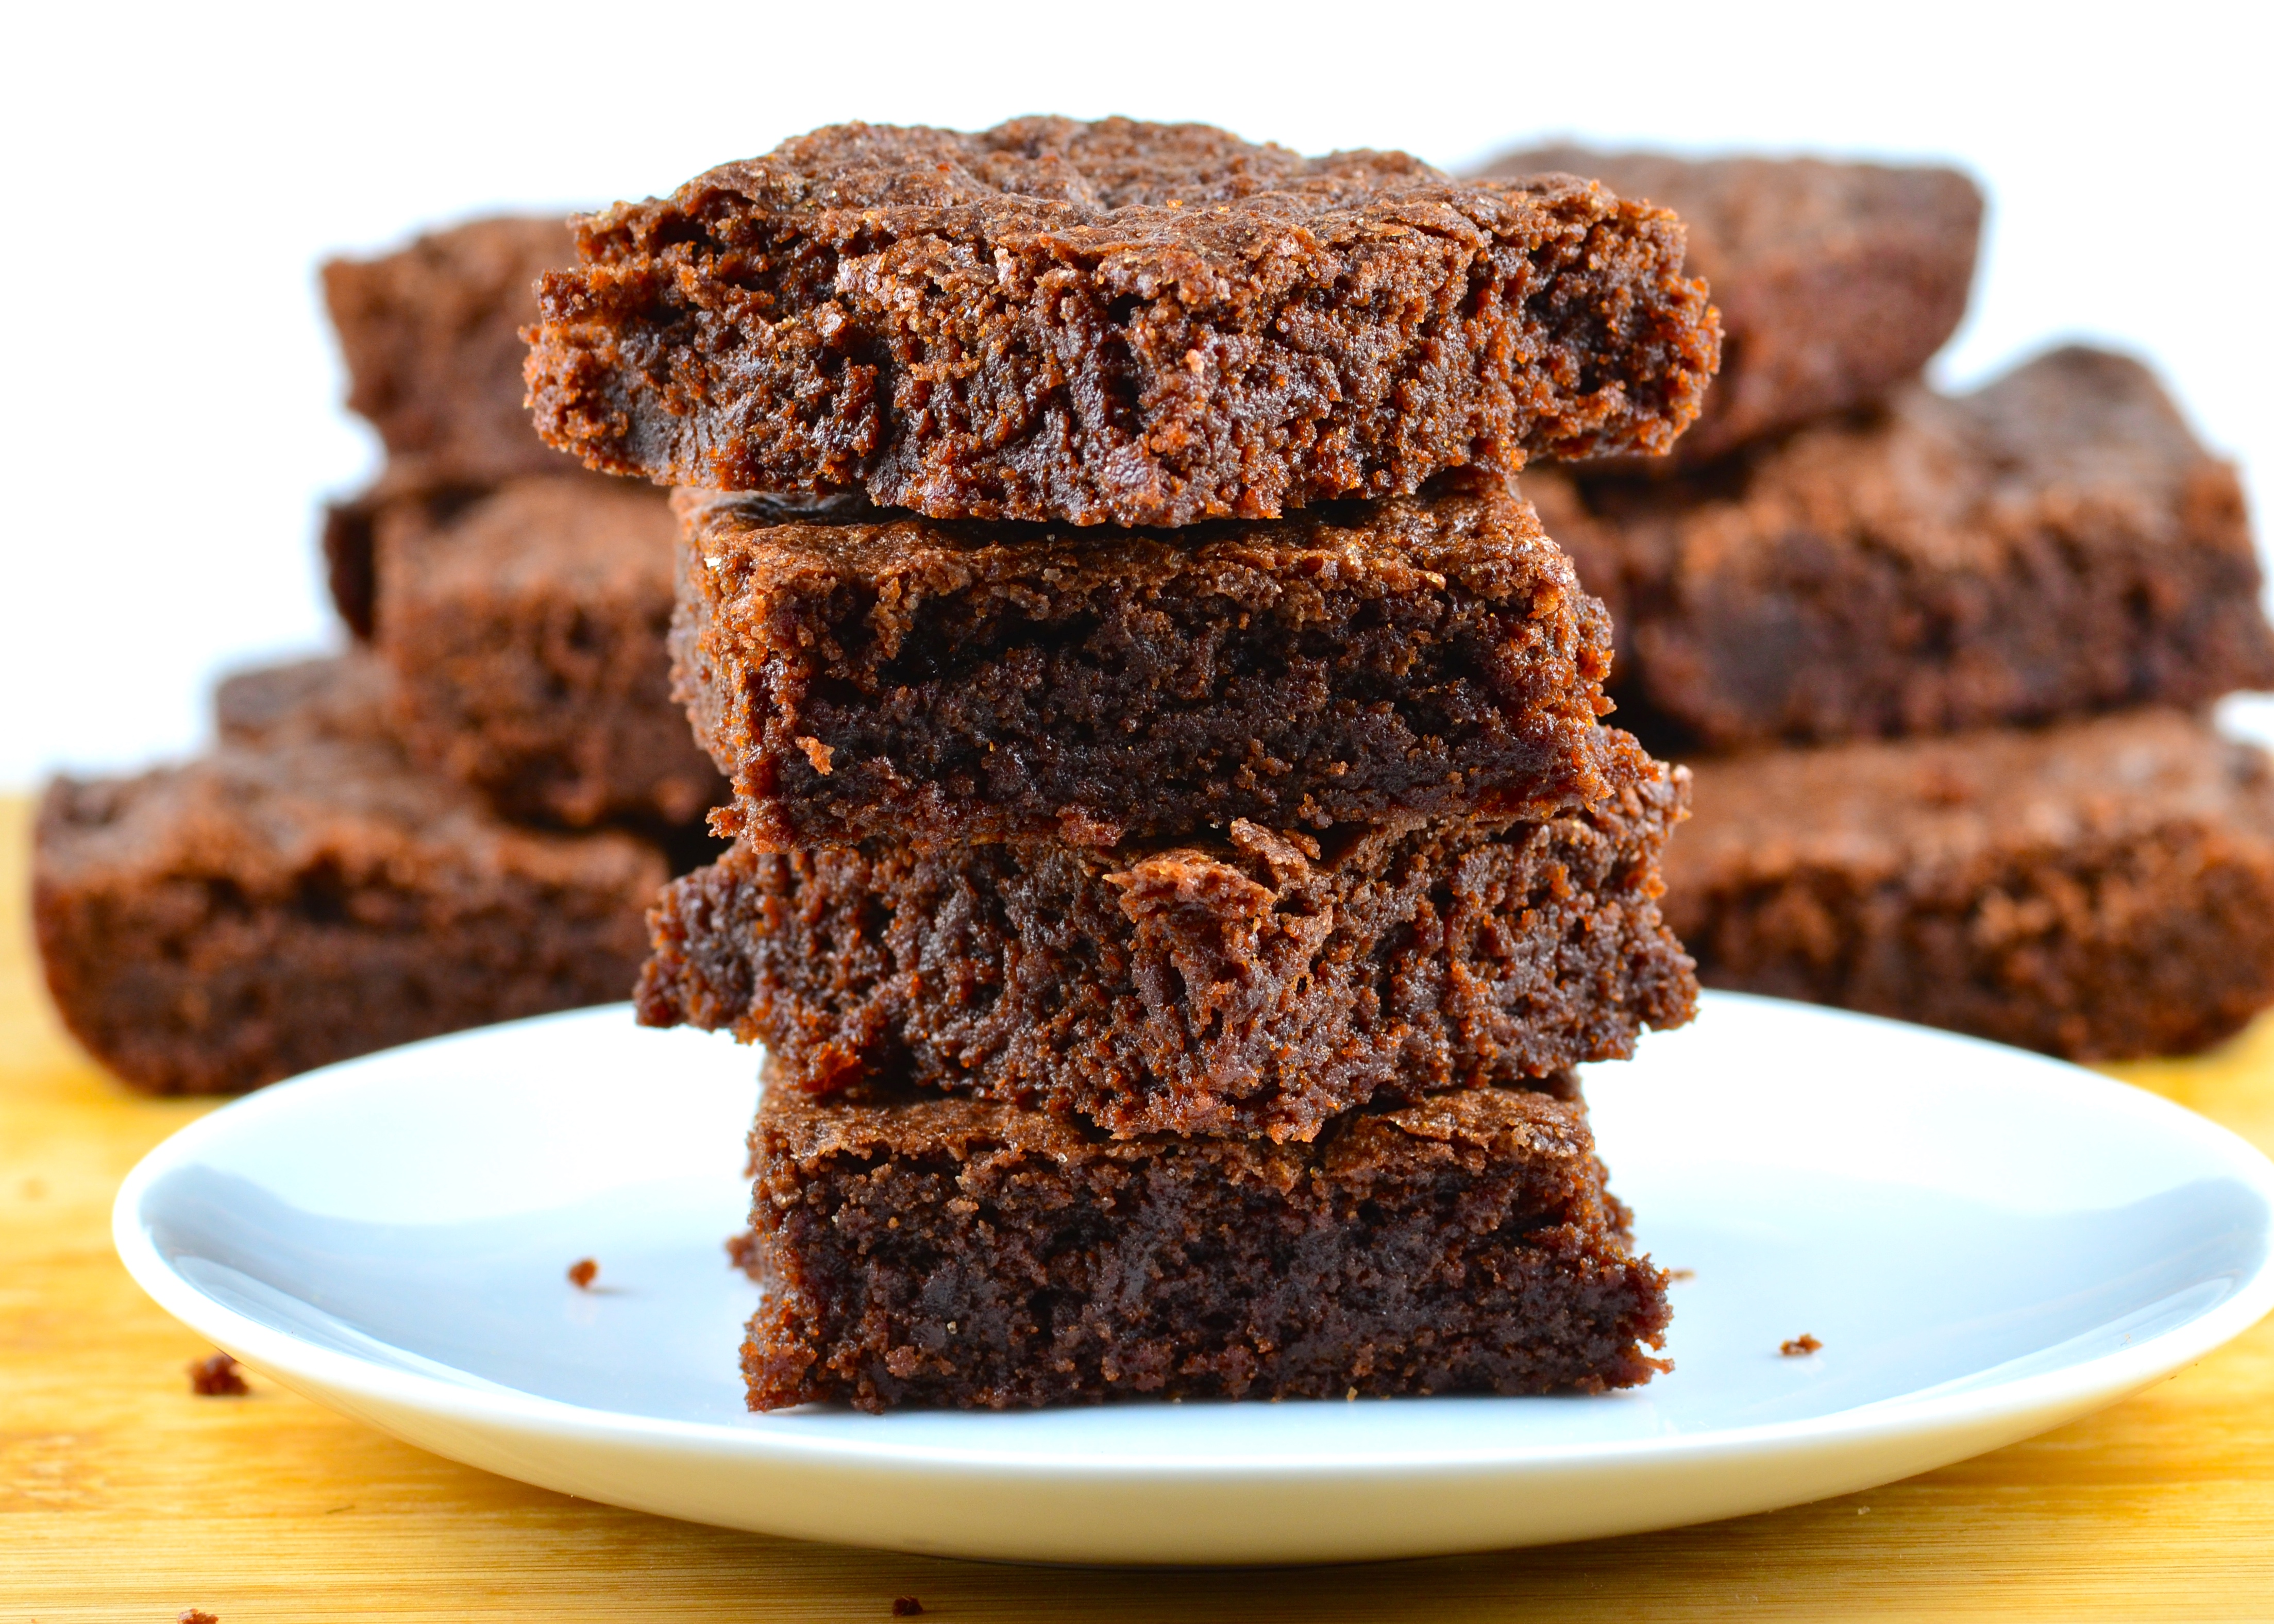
[114,996,2274,1563]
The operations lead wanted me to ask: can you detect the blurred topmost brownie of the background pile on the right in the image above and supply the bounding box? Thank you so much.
[1483,146,1983,464]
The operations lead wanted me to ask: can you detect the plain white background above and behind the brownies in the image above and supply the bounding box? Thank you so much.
[0,0,2274,787]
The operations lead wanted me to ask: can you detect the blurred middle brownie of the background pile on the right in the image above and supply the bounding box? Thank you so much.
[1524,348,2274,748]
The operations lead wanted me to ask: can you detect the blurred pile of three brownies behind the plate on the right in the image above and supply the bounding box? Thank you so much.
[1494,150,2274,1058]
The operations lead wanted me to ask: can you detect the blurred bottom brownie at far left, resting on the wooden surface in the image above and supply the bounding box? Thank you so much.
[32,662,666,1094]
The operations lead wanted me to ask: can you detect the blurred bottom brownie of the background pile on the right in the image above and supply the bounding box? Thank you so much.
[1664,709,2274,1060]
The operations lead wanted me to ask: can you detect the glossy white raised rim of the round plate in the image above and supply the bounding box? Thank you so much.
[111,992,2274,1483]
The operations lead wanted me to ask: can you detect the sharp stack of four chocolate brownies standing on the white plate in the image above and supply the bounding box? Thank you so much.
[528,119,1717,1408]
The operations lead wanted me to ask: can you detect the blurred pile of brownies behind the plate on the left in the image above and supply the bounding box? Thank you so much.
[34,206,723,1094]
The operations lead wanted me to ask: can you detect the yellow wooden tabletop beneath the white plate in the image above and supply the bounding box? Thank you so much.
[0,782,2274,1624]
